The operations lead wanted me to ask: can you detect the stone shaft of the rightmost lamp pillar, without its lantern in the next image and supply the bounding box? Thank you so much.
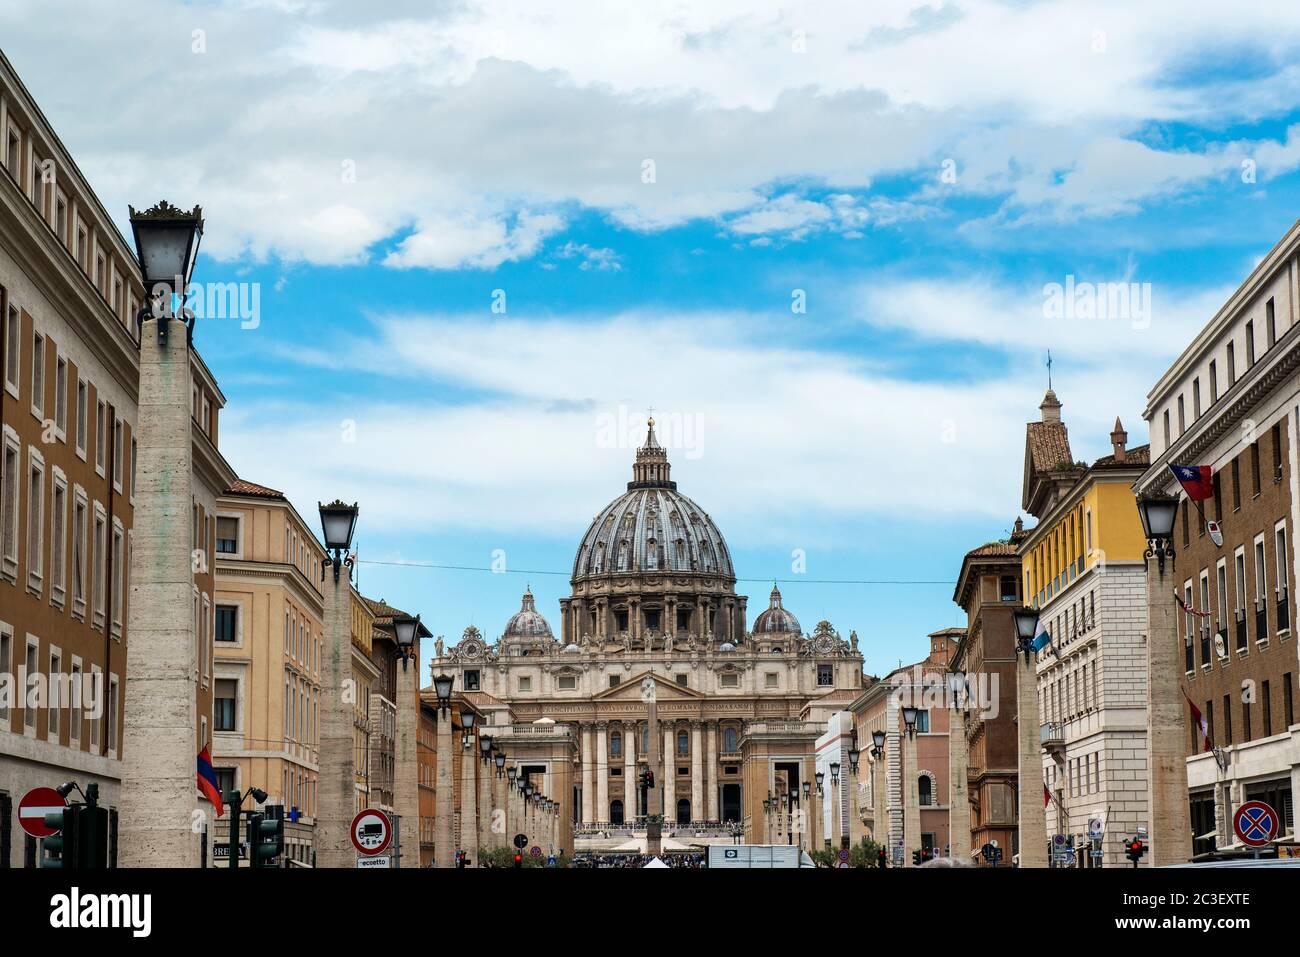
[1149,558,1192,867]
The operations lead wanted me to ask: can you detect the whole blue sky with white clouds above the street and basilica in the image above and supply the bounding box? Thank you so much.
[0,0,1300,674]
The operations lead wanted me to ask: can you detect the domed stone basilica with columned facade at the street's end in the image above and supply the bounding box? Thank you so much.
[430,419,862,853]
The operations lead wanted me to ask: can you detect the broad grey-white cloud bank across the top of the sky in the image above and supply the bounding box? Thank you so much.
[0,0,1300,268]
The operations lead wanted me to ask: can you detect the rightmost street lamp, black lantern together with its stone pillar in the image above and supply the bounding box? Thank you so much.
[1138,493,1192,867]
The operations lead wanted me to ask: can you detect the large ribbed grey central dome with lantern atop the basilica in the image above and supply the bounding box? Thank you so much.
[573,419,736,583]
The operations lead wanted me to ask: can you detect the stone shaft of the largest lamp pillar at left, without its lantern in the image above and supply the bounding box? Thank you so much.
[118,310,200,867]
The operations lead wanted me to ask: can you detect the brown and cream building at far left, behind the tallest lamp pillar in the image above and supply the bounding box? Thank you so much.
[0,55,235,866]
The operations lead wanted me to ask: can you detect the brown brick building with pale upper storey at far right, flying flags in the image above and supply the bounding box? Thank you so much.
[1136,224,1300,856]
